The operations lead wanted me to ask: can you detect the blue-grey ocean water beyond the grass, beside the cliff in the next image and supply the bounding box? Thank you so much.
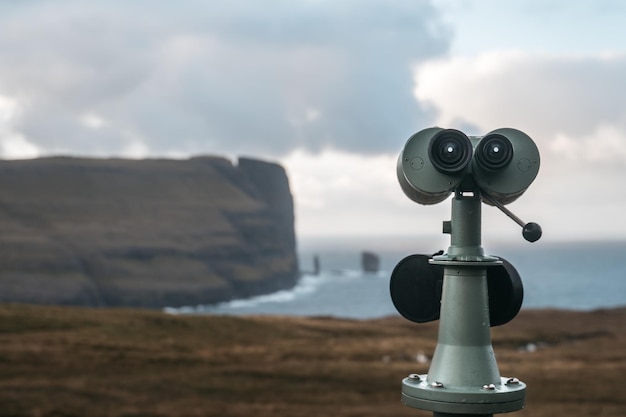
[166,238,626,319]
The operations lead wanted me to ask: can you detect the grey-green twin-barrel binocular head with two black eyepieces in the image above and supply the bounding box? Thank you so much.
[397,127,539,205]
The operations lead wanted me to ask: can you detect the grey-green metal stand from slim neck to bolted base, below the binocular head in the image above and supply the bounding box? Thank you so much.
[402,191,526,417]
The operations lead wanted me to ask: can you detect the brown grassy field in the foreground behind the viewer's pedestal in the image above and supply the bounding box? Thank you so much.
[0,305,626,417]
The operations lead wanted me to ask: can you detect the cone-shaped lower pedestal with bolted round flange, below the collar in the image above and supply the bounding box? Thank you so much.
[402,261,526,414]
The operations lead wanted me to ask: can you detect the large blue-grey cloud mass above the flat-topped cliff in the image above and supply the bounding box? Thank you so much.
[0,0,450,155]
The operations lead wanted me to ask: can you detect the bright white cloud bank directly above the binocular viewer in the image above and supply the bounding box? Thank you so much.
[415,51,626,149]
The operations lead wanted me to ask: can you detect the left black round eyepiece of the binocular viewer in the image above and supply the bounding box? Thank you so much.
[428,129,472,174]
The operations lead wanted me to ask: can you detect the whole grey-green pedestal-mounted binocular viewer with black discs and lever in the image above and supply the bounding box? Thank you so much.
[390,128,541,417]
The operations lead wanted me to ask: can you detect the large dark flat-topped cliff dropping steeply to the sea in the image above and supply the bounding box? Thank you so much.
[0,157,298,307]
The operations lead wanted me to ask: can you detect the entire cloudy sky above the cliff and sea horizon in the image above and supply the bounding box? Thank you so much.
[0,0,626,241]
